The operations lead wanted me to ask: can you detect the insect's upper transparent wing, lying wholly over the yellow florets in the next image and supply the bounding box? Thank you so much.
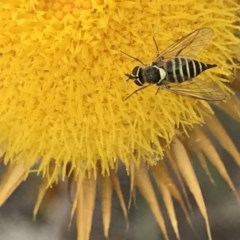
[153,27,213,65]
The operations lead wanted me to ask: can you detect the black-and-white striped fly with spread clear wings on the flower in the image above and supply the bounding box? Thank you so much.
[122,27,225,101]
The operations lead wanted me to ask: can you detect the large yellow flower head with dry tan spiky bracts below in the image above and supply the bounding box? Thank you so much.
[0,0,240,239]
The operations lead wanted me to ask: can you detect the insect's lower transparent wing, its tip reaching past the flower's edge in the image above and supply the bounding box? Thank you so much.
[159,80,227,101]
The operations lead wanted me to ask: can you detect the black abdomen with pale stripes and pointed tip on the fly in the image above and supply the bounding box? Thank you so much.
[163,58,217,82]
